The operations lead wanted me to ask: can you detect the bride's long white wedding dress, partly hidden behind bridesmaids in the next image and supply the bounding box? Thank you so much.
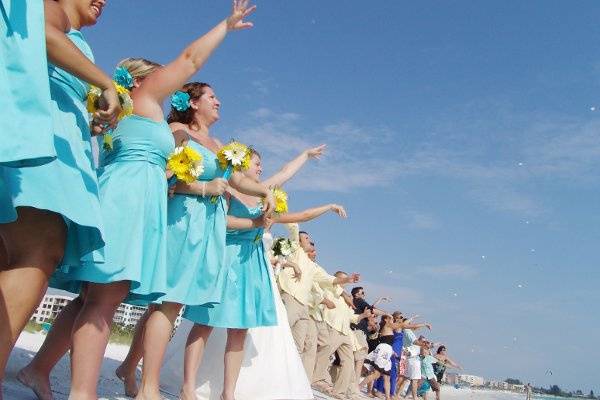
[161,232,314,400]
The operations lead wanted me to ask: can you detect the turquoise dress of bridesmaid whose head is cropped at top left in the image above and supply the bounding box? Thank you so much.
[0,29,104,265]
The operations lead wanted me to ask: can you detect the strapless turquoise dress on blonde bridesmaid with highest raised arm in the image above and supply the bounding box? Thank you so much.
[53,115,175,304]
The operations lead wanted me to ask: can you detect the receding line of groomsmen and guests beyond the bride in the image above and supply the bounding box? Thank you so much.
[278,225,460,399]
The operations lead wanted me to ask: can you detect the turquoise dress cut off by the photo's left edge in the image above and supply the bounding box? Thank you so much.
[0,0,56,168]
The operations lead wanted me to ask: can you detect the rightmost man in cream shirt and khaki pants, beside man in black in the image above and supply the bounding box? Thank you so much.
[313,271,366,398]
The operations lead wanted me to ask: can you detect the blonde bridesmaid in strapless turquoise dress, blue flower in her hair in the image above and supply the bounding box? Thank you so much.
[18,58,168,399]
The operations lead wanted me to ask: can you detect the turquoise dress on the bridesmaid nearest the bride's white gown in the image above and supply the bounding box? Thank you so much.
[183,197,277,329]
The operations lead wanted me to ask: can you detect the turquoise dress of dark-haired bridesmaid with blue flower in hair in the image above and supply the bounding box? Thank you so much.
[160,140,227,305]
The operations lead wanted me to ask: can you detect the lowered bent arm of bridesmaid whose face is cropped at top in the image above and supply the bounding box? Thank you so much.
[44,0,121,123]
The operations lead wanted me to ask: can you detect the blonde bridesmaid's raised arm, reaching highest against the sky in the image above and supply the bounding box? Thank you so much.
[134,0,256,119]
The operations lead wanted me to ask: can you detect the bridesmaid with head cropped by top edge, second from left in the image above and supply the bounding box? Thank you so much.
[0,0,120,394]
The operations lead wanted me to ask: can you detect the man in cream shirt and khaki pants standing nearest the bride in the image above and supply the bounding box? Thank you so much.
[278,224,358,381]
